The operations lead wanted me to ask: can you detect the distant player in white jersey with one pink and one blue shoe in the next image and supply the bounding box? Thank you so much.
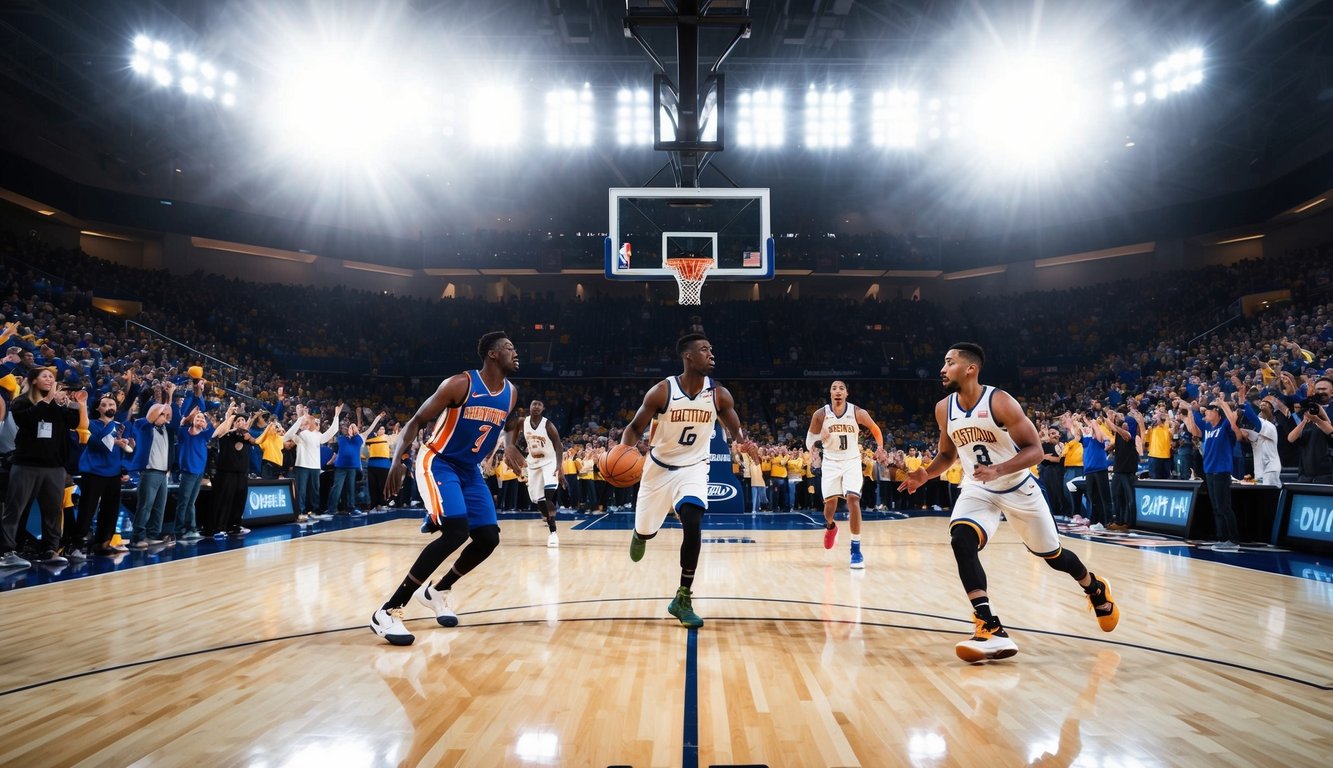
[805,381,889,569]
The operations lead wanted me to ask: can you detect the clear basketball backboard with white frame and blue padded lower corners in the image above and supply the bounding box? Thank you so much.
[605,187,774,280]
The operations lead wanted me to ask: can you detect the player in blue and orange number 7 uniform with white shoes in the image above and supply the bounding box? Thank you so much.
[371,331,524,645]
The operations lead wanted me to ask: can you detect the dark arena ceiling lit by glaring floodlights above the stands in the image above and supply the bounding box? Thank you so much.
[0,0,1333,256]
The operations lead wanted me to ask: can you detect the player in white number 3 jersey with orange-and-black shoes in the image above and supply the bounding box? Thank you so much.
[898,343,1120,663]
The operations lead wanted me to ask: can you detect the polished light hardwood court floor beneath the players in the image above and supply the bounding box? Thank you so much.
[0,517,1333,768]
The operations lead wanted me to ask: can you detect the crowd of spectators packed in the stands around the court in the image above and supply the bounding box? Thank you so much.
[0,221,1333,557]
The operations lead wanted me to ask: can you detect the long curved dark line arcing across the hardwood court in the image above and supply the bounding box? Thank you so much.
[0,596,1333,699]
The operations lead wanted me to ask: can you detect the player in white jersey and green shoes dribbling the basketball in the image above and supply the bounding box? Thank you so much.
[620,333,741,627]
